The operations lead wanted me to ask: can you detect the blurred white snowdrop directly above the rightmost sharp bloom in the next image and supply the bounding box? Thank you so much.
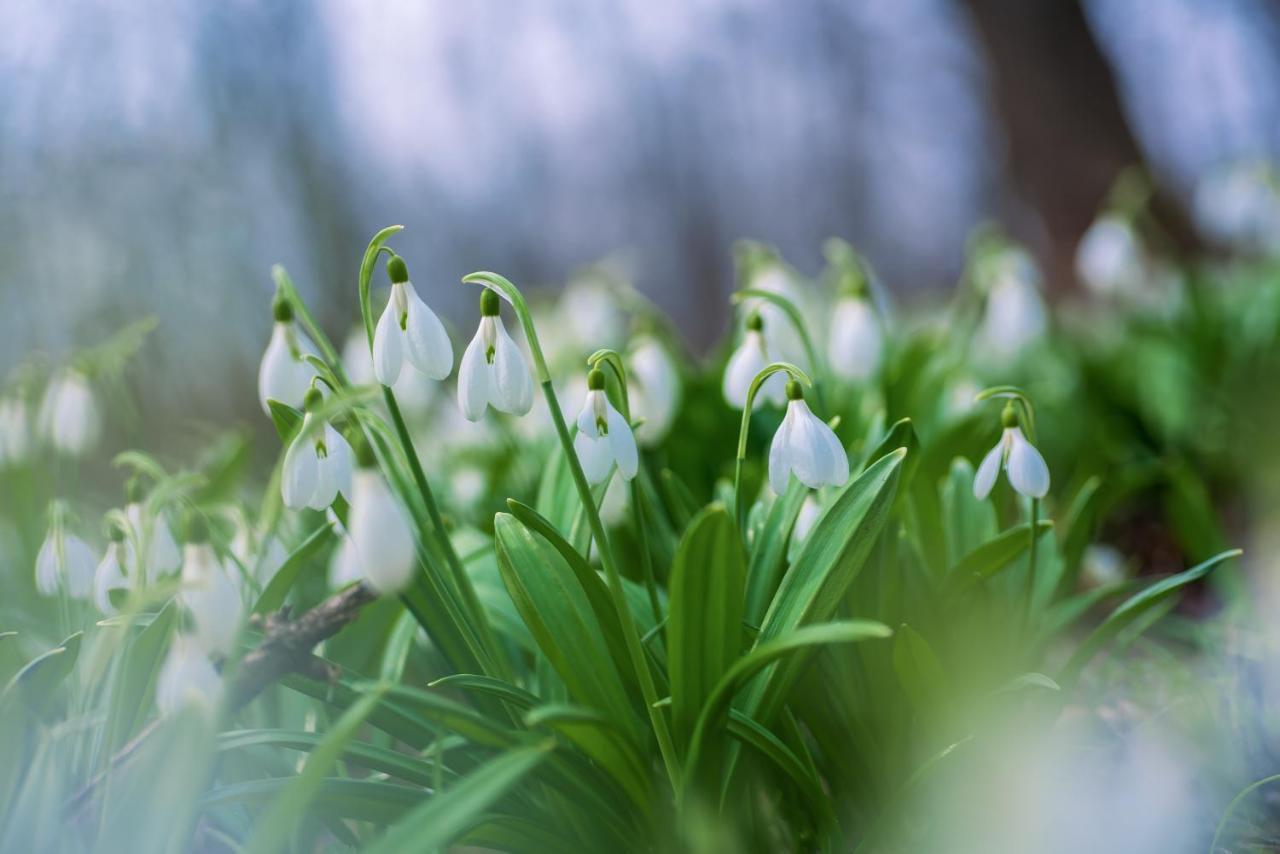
[978,248,1047,359]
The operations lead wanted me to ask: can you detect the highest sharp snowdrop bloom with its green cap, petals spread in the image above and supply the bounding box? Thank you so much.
[374,255,453,387]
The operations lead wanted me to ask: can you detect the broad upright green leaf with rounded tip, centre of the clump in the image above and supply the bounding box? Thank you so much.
[667,504,746,746]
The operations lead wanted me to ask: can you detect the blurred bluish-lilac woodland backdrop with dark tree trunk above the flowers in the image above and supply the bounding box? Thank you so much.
[0,0,1280,434]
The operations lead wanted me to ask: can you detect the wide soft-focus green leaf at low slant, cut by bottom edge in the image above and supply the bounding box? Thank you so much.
[367,743,553,854]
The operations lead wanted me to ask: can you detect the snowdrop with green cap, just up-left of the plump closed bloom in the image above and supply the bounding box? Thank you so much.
[280,388,352,510]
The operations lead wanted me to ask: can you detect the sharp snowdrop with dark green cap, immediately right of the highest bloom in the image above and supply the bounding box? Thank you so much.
[458,288,534,421]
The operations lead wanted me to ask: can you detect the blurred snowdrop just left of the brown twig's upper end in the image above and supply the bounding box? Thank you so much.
[180,512,242,656]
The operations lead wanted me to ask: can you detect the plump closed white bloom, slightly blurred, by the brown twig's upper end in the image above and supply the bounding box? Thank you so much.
[348,466,416,593]
